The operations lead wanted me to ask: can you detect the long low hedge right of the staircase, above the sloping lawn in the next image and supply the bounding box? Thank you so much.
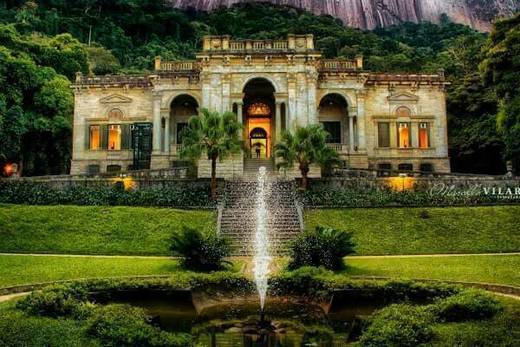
[299,185,518,208]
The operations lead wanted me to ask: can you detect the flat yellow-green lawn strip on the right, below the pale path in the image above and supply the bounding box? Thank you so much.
[346,255,520,286]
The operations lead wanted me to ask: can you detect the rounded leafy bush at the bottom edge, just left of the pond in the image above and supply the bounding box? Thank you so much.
[87,305,191,347]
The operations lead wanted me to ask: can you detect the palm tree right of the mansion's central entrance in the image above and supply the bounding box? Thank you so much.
[275,124,339,189]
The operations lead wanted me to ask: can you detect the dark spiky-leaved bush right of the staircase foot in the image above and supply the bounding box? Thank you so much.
[289,226,355,270]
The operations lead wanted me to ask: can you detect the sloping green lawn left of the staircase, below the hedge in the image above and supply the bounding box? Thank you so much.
[0,205,216,255]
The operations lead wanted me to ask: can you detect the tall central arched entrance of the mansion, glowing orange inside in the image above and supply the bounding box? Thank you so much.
[243,78,275,158]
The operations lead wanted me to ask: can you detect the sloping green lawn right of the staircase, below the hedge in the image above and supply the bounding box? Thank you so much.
[305,206,520,255]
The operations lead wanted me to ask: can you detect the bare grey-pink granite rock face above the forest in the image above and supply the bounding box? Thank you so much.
[169,0,520,31]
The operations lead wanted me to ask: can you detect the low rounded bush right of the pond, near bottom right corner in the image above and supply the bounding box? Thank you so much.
[433,290,503,322]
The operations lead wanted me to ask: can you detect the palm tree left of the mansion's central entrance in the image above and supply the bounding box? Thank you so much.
[180,109,242,199]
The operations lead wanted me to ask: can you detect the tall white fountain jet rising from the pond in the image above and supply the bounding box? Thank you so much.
[253,166,272,312]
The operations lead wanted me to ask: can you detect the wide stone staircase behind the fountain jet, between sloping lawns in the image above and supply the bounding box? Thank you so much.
[219,176,303,256]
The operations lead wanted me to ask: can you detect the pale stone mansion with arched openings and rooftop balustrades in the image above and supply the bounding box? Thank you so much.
[71,35,450,178]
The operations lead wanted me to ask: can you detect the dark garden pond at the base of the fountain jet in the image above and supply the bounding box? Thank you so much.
[109,292,384,347]
